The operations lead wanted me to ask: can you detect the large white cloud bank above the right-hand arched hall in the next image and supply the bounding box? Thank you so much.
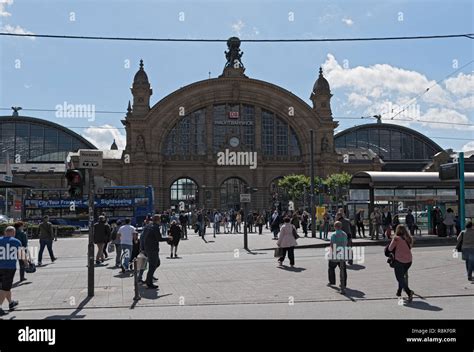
[322,54,474,130]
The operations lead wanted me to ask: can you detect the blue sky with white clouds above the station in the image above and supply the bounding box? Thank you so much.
[0,0,474,151]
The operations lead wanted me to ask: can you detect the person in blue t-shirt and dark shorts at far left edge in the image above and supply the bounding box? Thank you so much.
[0,226,26,316]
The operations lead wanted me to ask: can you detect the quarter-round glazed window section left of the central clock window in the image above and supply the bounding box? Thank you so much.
[164,109,206,157]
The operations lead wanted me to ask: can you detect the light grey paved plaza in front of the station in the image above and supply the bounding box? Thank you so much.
[3,231,474,319]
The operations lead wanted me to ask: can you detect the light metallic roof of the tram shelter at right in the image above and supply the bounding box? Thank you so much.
[351,171,474,188]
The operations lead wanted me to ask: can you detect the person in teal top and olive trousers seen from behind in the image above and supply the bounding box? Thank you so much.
[328,221,352,294]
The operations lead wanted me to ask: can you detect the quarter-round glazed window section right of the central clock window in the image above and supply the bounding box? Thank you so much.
[262,110,301,158]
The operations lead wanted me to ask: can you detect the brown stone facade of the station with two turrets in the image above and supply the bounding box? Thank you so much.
[103,41,380,210]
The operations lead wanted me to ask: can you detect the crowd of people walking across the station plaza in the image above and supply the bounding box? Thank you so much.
[0,208,474,315]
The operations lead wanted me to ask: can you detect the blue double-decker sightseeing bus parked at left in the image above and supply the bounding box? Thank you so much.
[23,186,154,227]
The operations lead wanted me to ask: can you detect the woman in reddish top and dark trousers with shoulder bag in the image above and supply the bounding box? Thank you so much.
[388,225,413,302]
